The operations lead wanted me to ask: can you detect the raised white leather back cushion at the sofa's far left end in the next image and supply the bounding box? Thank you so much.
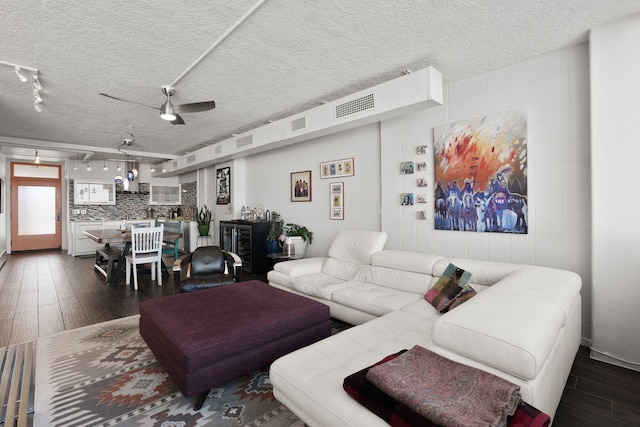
[329,230,387,264]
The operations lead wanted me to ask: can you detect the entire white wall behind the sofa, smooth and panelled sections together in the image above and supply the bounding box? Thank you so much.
[235,44,591,339]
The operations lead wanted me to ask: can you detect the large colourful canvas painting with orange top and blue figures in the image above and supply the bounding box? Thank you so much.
[433,110,528,234]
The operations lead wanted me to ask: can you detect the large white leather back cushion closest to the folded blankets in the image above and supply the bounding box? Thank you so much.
[432,285,566,380]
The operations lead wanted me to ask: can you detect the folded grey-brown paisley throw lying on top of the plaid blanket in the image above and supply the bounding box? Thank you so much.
[367,346,520,427]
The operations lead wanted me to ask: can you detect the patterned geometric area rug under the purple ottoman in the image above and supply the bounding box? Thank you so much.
[34,316,322,427]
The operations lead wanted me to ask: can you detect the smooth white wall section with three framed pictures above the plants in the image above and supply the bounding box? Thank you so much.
[240,124,380,256]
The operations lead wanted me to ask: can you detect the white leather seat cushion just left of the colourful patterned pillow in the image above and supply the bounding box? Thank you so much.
[331,282,423,317]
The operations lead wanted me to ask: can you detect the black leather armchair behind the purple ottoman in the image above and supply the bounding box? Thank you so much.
[173,246,242,292]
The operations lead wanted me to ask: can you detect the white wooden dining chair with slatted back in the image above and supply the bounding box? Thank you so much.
[126,224,164,290]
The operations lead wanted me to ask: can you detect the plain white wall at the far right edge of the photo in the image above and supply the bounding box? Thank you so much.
[590,11,640,370]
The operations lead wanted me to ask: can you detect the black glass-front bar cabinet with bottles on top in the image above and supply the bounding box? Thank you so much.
[220,220,271,274]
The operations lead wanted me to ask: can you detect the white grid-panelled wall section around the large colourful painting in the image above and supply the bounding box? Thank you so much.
[381,44,591,344]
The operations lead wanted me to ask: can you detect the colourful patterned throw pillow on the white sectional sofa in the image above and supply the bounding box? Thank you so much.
[424,264,476,313]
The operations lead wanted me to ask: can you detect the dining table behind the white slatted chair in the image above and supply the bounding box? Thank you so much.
[83,229,182,285]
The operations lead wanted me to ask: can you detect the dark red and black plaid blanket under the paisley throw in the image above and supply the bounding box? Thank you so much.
[343,350,551,427]
